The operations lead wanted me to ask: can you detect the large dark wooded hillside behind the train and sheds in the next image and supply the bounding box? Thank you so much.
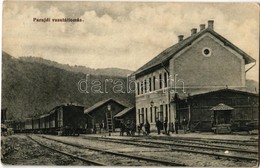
[2,52,135,120]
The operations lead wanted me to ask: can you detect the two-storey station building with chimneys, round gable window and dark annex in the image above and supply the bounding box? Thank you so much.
[133,20,259,131]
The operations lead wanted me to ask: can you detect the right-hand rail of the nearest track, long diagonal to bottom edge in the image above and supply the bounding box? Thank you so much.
[35,136,185,166]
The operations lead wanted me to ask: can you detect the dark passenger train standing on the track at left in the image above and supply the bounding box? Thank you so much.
[14,104,86,135]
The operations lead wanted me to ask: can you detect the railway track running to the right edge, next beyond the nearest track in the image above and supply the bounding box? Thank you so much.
[84,137,257,161]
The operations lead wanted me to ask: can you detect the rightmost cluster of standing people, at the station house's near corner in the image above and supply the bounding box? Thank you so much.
[155,117,188,135]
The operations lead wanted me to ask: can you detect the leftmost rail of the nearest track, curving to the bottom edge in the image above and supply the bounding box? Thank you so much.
[27,135,107,166]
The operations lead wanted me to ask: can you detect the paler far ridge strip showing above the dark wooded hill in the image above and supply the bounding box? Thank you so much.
[19,56,133,77]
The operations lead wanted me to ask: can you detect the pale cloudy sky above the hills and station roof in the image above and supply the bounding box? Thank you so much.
[2,1,259,81]
